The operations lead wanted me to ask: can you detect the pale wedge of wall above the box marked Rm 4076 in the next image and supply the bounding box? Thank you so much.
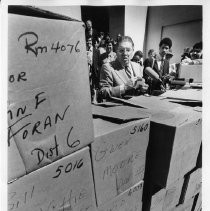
[39,6,82,20]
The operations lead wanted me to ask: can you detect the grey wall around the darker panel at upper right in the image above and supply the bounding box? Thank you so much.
[144,6,202,61]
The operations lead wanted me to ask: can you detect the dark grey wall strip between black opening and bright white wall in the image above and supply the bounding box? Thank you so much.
[109,6,125,39]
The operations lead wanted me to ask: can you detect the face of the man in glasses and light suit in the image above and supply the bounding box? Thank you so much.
[117,41,133,66]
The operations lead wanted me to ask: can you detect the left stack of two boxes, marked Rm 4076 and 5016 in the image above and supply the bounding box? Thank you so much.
[8,6,96,211]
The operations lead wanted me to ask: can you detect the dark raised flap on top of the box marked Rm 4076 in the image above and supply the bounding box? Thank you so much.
[8,5,81,22]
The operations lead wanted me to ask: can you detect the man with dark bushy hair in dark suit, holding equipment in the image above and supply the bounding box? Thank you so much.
[144,38,172,94]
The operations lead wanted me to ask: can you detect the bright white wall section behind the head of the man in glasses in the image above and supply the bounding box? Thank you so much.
[124,6,147,51]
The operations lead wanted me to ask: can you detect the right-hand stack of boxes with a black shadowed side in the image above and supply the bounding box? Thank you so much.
[109,96,202,211]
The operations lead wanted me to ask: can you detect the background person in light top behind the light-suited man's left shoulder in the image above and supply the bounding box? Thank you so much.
[100,41,117,64]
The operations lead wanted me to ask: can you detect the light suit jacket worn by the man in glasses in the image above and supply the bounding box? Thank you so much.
[100,60,143,98]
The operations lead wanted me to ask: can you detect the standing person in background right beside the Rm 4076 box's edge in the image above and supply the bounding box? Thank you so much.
[86,36,100,103]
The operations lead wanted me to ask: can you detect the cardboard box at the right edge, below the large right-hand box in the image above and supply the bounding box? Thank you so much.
[184,168,202,201]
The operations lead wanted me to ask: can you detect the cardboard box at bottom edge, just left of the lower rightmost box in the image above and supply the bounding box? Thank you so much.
[163,177,184,210]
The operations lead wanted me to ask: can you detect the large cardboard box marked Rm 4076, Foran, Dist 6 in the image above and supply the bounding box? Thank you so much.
[8,6,93,172]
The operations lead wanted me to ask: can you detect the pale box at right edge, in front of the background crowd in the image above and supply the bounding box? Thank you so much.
[178,64,203,82]
